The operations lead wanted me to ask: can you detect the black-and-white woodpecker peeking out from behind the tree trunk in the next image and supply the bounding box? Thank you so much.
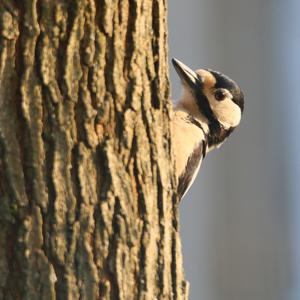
[171,58,244,200]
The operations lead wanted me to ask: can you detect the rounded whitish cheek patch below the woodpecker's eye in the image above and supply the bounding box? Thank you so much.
[207,95,242,128]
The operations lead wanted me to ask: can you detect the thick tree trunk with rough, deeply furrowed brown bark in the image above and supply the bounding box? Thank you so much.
[0,0,187,300]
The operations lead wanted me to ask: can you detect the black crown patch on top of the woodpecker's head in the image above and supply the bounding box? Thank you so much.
[207,69,244,112]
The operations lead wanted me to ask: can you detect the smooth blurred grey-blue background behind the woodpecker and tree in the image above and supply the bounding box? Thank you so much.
[169,0,300,300]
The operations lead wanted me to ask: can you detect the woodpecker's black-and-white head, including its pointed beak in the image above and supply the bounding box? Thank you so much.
[172,58,244,146]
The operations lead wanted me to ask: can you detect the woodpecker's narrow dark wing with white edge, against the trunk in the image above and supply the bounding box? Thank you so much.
[177,141,206,199]
